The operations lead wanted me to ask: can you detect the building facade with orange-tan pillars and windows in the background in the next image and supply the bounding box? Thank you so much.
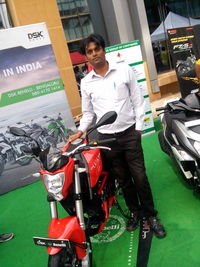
[0,0,200,115]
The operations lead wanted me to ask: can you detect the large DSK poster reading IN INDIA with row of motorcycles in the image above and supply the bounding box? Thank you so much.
[0,23,75,194]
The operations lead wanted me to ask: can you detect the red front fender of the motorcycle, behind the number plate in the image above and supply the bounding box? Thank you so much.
[47,216,86,259]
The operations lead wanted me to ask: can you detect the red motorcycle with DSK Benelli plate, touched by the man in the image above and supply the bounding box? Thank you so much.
[10,111,120,267]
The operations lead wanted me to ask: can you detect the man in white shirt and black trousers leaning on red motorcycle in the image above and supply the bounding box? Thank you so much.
[69,34,166,238]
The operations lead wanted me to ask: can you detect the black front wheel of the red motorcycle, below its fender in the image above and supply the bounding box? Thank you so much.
[48,237,92,267]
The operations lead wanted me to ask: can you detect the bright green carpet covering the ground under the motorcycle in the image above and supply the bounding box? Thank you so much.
[0,122,200,267]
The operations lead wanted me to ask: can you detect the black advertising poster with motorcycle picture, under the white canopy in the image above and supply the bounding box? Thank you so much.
[168,25,200,97]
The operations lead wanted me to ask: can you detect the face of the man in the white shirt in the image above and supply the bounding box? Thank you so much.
[85,42,106,68]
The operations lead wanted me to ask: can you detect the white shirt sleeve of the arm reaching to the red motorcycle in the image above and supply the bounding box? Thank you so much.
[78,80,95,133]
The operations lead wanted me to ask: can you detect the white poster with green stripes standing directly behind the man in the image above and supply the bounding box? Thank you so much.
[106,41,155,135]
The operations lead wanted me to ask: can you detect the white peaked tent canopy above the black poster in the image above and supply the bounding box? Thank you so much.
[151,11,200,41]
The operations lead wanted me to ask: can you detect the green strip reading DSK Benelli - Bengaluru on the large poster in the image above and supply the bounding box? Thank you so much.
[0,78,64,107]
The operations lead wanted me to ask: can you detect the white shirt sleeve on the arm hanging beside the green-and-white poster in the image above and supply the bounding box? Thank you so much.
[128,66,145,131]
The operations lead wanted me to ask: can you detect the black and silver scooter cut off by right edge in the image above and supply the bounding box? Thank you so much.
[156,93,200,193]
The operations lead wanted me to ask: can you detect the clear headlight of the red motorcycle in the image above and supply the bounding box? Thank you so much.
[43,172,65,201]
